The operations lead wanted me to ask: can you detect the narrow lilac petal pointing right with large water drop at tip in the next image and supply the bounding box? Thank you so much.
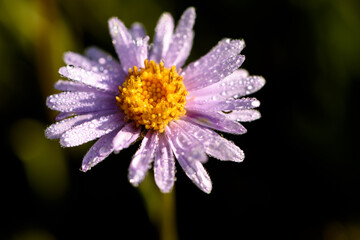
[186,96,260,111]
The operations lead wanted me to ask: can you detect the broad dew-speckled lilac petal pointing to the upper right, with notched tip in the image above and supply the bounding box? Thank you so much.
[182,39,245,90]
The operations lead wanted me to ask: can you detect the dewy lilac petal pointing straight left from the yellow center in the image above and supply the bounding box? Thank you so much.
[46,92,117,113]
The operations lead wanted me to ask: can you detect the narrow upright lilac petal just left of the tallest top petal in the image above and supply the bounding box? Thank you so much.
[150,13,174,63]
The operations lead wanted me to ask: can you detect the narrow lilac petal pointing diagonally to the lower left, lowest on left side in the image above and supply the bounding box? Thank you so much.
[81,129,117,172]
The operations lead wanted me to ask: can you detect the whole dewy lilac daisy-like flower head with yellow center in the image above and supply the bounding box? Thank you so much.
[45,7,265,193]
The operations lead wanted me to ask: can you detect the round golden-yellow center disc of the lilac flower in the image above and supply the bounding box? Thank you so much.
[116,59,188,132]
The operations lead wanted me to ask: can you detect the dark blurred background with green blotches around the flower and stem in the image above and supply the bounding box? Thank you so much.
[0,0,360,240]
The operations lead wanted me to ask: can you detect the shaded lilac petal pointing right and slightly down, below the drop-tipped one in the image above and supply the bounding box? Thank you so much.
[182,110,246,134]
